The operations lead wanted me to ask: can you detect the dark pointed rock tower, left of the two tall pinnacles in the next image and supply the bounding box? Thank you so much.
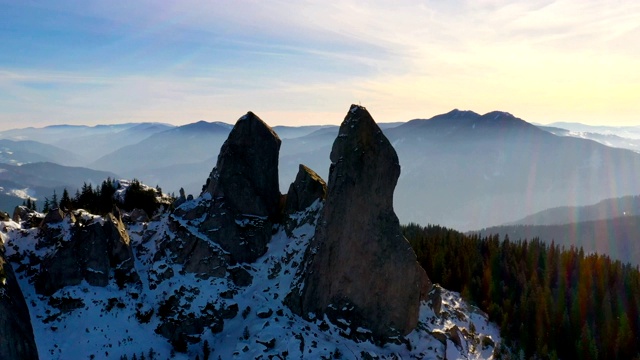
[175,112,281,263]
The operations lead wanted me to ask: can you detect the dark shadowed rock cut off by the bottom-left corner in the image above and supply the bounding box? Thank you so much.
[0,249,38,360]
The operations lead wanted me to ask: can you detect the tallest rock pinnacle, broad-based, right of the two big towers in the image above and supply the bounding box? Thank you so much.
[287,105,431,342]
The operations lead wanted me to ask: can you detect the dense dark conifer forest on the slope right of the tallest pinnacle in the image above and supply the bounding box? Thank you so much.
[403,224,640,359]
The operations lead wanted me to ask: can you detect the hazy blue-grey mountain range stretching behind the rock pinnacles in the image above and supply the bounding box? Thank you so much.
[0,110,640,231]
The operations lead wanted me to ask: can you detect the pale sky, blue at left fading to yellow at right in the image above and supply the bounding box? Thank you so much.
[0,0,640,130]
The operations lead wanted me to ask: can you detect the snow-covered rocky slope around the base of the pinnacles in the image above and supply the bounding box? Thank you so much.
[0,202,500,359]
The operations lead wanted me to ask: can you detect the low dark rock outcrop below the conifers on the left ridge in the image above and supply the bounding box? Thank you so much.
[35,212,139,295]
